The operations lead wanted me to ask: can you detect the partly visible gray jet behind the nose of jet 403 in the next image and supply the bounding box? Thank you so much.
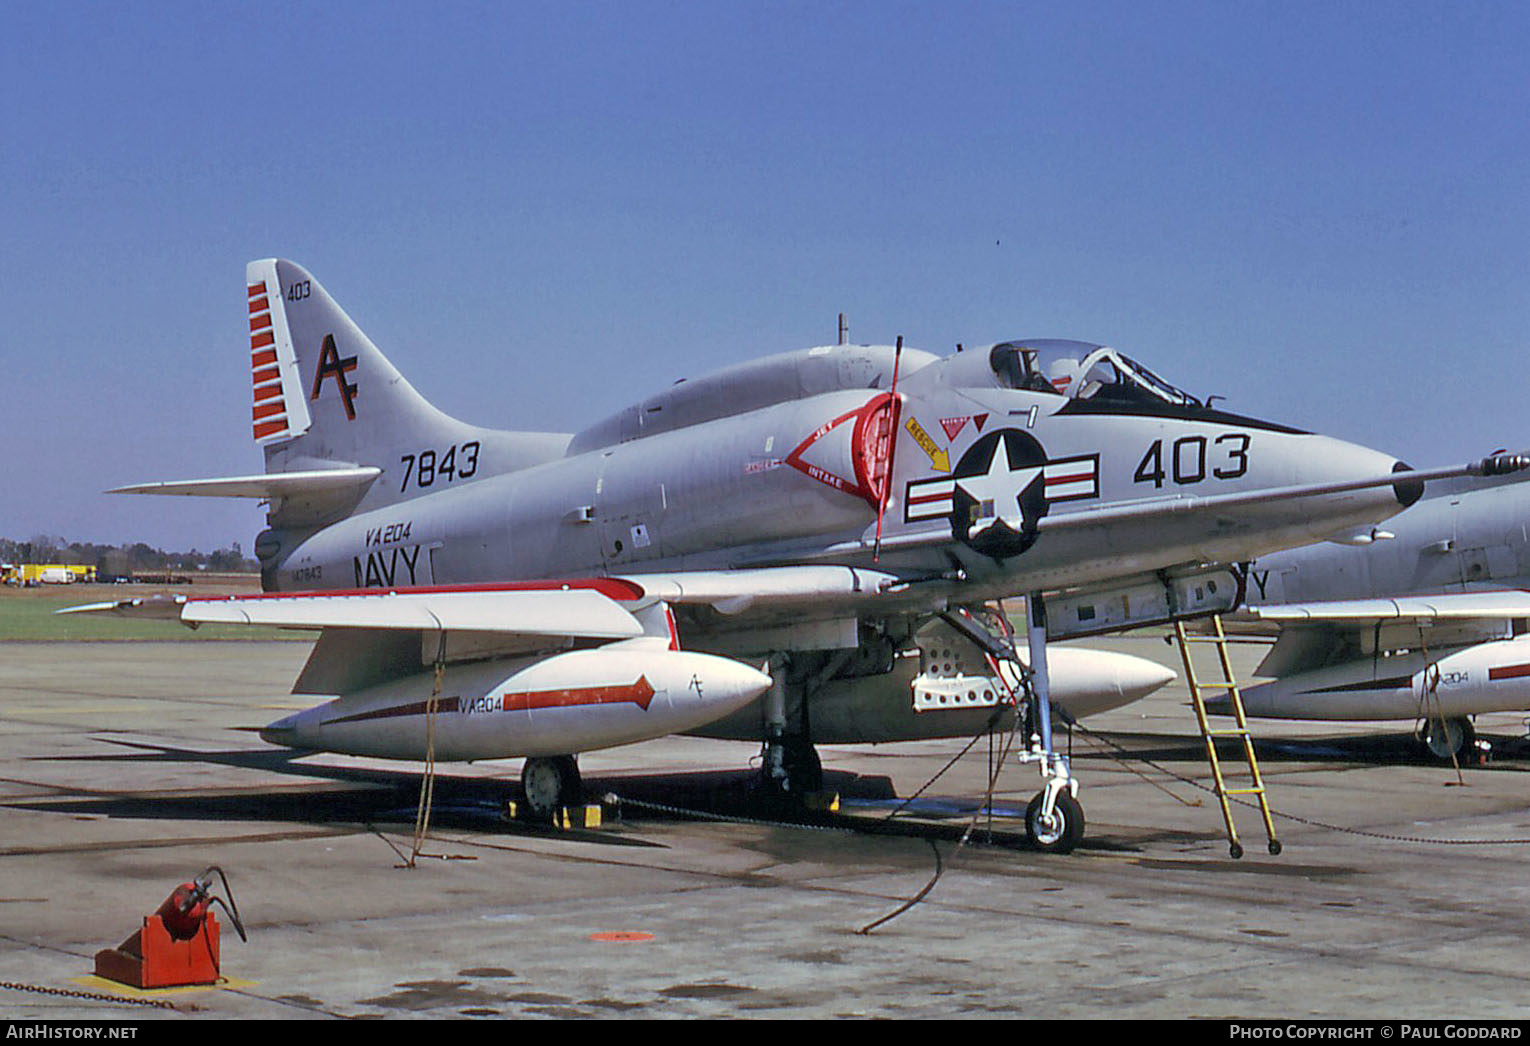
[1242,467,1530,759]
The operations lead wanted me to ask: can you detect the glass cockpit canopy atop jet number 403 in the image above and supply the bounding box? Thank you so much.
[988,339,1203,407]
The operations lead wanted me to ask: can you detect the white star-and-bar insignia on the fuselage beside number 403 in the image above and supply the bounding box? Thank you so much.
[903,428,1100,558]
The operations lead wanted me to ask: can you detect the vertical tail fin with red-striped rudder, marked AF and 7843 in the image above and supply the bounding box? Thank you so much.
[245,258,569,511]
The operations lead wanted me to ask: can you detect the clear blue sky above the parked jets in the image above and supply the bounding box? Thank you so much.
[0,0,1530,551]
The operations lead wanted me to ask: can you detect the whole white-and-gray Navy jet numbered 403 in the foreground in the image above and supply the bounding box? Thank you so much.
[86,260,1521,850]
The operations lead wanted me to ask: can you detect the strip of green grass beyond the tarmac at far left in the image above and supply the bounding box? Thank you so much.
[0,581,302,642]
